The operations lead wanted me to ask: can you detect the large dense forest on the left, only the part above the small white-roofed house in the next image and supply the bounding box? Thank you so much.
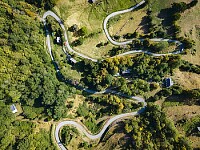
[0,1,75,119]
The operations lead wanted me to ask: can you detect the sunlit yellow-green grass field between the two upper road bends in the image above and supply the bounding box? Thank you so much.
[54,0,140,59]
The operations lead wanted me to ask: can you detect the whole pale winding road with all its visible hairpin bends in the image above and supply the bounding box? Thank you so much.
[43,0,183,150]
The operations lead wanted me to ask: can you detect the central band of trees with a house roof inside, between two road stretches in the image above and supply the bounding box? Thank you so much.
[81,54,181,91]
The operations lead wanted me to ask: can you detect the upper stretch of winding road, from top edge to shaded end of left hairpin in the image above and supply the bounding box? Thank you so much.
[43,0,183,62]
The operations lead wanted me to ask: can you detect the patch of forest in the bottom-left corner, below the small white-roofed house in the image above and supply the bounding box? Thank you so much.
[0,101,56,150]
